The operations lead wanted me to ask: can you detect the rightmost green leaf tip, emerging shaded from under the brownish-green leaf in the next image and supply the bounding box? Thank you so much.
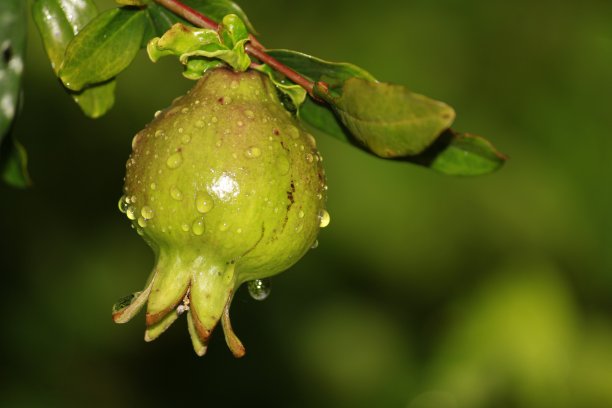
[404,129,507,176]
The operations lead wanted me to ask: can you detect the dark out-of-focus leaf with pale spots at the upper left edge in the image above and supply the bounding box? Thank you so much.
[0,0,27,143]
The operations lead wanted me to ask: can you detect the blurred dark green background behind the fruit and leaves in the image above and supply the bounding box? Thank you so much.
[0,0,612,408]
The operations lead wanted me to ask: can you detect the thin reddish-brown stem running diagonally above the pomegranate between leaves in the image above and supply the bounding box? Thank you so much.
[154,0,319,100]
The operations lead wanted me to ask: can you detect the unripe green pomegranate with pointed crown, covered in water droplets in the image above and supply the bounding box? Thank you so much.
[113,69,327,356]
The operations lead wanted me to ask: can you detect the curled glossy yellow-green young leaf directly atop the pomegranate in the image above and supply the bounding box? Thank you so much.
[147,15,251,79]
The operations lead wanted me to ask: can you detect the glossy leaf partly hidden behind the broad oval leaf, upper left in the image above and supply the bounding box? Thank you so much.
[32,0,115,118]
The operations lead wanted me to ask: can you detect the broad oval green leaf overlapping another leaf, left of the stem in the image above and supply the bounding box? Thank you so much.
[59,8,147,91]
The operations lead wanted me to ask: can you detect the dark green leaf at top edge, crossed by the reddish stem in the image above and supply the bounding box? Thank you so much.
[147,0,257,38]
